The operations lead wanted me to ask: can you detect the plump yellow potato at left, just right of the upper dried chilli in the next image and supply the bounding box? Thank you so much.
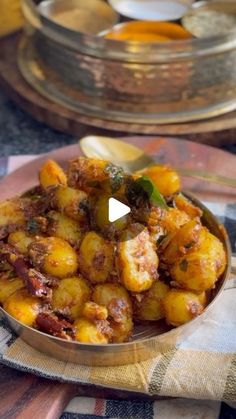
[29,237,78,278]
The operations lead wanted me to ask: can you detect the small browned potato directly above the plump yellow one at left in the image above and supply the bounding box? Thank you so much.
[47,211,82,247]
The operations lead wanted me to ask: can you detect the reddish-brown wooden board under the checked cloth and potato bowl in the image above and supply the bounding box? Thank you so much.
[0,137,236,419]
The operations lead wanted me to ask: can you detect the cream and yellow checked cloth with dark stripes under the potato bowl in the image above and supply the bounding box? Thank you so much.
[0,156,236,419]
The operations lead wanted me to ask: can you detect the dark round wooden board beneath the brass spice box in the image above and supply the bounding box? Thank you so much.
[0,35,236,146]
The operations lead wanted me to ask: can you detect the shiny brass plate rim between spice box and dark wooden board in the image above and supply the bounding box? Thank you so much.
[17,36,236,126]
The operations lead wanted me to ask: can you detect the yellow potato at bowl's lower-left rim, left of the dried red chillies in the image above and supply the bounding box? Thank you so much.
[3,289,42,326]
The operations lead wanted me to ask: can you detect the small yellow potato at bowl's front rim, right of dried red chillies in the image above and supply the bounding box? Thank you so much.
[74,317,109,344]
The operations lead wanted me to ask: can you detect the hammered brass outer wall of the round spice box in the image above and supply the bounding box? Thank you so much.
[19,0,236,124]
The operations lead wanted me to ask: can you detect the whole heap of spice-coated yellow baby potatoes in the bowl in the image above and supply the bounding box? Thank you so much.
[0,157,226,344]
